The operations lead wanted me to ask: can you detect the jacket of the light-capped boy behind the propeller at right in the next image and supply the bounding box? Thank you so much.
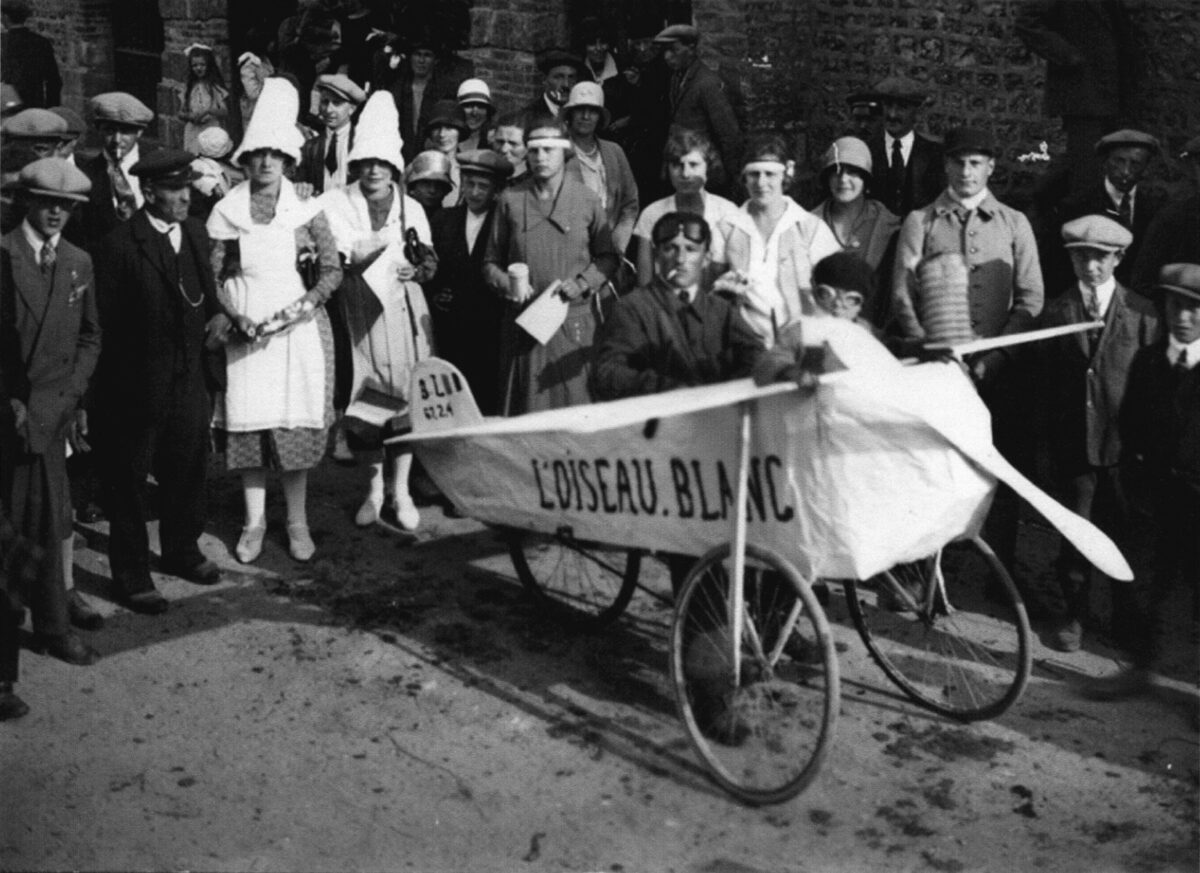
[1038,283,1159,475]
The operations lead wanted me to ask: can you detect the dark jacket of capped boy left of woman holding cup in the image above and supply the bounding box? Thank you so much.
[426,204,505,415]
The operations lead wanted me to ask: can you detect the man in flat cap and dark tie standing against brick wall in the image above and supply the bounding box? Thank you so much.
[848,76,946,218]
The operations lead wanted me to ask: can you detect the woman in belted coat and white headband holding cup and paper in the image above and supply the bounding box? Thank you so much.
[484,116,619,415]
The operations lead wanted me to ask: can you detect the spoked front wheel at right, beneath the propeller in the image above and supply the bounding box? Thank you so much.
[846,537,1032,722]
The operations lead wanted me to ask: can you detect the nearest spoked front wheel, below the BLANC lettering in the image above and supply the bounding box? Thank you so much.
[671,544,839,805]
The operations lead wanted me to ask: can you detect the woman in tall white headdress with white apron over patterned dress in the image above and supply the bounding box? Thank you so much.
[206,78,342,564]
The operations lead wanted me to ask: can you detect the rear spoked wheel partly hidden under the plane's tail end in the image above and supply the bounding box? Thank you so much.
[508,531,642,630]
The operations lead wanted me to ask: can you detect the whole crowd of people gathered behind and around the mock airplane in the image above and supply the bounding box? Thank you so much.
[0,4,1200,738]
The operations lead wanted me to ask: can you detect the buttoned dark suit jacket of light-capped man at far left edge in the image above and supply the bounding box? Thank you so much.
[0,227,100,454]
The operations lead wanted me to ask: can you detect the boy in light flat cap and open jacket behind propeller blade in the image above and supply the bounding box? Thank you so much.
[1038,215,1159,652]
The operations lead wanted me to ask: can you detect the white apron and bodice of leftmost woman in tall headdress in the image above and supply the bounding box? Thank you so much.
[209,180,331,433]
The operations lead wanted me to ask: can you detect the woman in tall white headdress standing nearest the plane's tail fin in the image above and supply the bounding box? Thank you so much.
[320,91,437,530]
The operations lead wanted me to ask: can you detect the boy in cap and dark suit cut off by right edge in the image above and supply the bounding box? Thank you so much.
[1084,264,1200,700]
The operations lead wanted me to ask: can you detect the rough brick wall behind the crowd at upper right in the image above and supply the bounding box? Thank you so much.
[694,0,1200,200]
